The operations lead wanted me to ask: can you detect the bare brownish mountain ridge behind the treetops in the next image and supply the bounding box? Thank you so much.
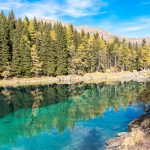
[38,18,150,44]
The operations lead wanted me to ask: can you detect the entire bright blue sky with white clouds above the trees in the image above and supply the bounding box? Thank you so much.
[0,0,150,37]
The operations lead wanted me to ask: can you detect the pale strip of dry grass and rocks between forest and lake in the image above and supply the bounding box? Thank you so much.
[0,70,150,87]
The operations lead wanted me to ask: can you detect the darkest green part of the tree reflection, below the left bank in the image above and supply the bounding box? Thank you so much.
[0,85,67,118]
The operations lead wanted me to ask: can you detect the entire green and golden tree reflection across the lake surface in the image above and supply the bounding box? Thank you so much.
[0,82,146,144]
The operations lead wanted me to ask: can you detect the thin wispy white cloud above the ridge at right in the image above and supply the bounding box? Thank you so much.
[100,17,150,37]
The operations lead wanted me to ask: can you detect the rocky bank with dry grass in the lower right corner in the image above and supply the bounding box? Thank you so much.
[106,107,150,150]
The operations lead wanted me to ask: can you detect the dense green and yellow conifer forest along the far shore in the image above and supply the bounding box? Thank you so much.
[0,11,150,78]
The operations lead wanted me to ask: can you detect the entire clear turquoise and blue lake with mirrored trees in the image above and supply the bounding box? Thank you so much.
[0,82,149,150]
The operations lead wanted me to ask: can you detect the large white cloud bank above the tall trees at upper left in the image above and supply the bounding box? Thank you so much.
[0,0,107,18]
